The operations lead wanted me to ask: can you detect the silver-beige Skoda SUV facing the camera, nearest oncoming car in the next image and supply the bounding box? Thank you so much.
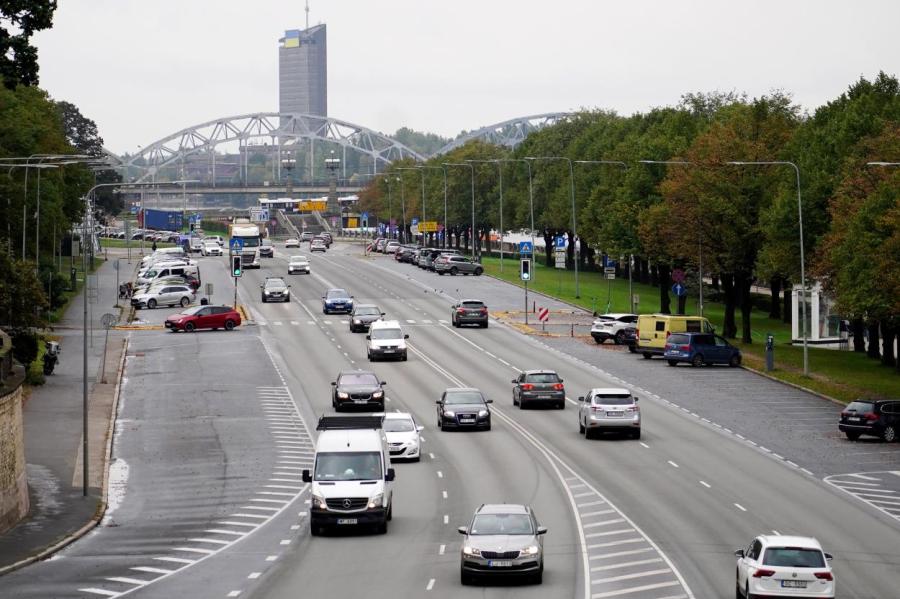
[459,504,547,584]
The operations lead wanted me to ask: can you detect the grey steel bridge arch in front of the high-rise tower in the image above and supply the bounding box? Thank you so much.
[114,112,424,180]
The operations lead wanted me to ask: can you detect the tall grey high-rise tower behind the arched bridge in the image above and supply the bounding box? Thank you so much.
[278,25,328,116]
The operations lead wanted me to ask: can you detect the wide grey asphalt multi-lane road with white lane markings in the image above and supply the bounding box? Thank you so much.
[0,242,900,599]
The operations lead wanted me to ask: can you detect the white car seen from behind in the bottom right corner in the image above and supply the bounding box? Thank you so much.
[734,535,834,599]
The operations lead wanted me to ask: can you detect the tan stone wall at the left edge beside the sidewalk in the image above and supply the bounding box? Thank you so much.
[0,384,28,534]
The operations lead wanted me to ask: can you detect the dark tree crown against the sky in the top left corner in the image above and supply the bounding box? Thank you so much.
[0,0,56,89]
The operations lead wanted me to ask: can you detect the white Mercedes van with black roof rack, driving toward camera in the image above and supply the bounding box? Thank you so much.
[303,416,394,535]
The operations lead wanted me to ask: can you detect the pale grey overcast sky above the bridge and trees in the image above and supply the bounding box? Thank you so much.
[34,0,900,153]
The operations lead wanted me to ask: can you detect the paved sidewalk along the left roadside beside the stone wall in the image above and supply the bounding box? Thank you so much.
[0,249,133,574]
